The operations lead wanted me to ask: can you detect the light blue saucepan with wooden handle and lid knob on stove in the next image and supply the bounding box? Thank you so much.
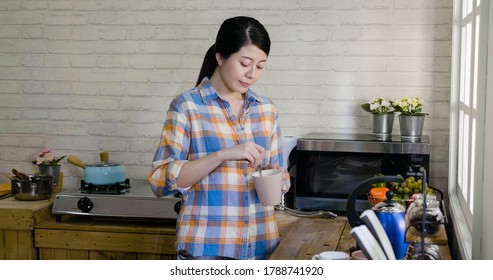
[67,152,126,186]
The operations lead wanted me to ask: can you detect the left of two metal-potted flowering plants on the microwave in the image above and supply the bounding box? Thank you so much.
[361,98,395,140]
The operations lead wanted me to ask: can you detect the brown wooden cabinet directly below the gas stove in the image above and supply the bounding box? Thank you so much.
[35,216,176,260]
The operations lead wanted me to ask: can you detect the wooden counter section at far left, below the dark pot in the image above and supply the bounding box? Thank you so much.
[0,197,53,260]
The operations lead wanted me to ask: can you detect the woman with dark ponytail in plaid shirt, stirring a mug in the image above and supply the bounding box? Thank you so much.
[148,17,289,259]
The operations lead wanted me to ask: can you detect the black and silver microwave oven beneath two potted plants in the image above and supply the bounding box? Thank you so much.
[290,134,430,211]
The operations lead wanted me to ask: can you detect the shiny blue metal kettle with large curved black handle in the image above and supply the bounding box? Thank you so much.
[346,176,409,259]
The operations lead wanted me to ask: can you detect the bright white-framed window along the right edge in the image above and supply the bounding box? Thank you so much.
[449,0,489,259]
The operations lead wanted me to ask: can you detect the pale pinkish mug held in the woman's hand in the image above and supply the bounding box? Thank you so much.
[252,169,282,206]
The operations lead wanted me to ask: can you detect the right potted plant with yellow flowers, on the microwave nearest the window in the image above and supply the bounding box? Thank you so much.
[393,96,428,140]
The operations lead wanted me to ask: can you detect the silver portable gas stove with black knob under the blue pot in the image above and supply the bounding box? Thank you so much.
[52,179,181,222]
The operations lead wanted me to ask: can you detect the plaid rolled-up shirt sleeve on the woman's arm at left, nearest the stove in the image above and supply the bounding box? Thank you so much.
[147,98,190,197]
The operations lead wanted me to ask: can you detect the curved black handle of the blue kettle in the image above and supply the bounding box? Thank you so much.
[346,175,404,228]
